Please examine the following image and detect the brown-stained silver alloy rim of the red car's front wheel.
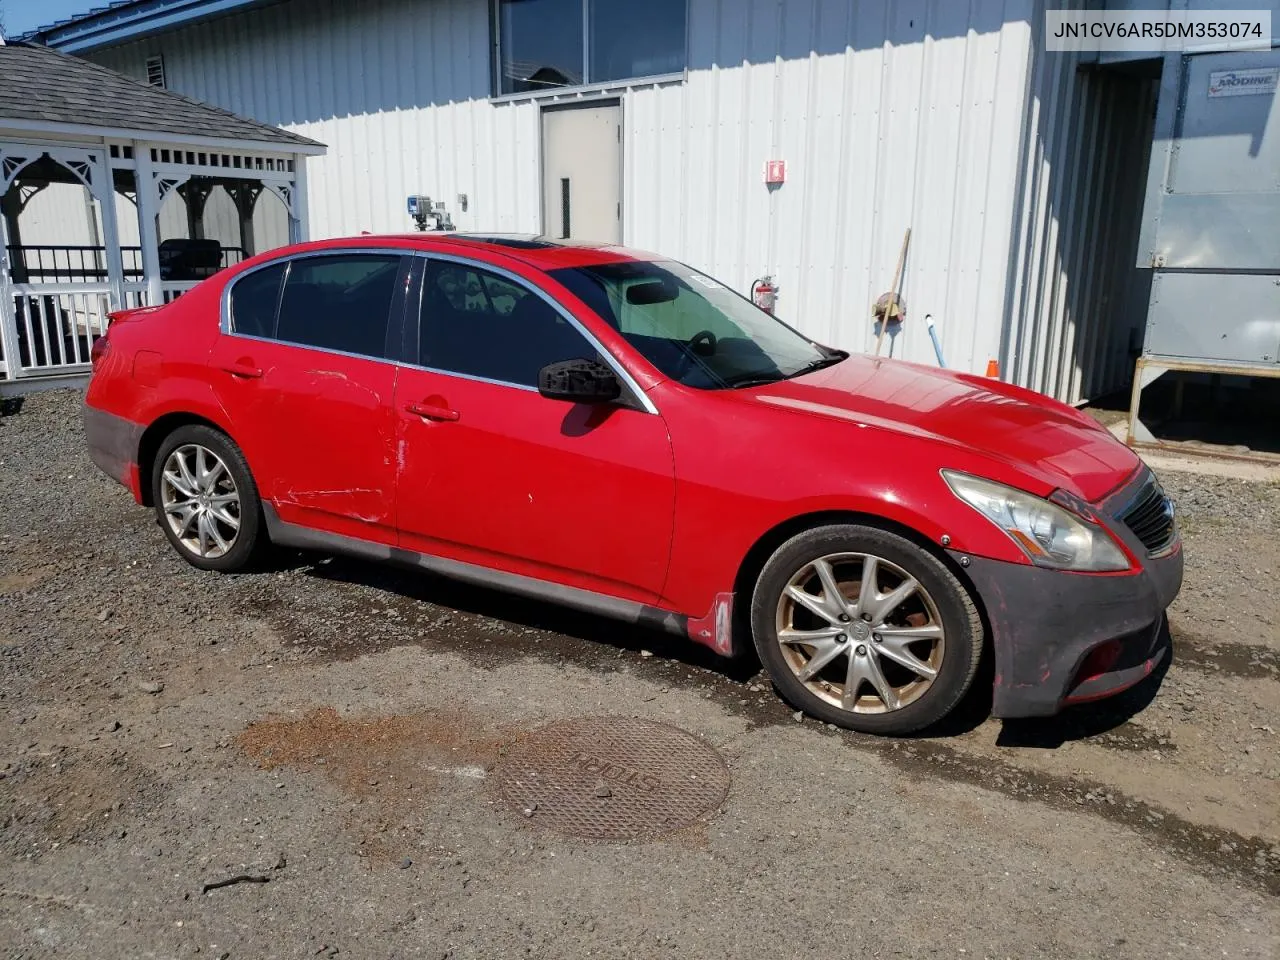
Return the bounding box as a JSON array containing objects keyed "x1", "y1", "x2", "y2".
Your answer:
[{"x1": 776, "y1": 553, "x2": 946, "y2": 713}]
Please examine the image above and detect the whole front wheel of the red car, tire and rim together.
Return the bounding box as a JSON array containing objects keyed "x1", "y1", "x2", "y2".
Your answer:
[{"x1": 751, "y1": 525, "x2": 983, "y2": 736}]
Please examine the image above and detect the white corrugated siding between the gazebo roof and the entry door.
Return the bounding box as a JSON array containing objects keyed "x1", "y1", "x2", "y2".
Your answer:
[{"x1": 91, "y1": 0, "x2": 540, "y2": 237}]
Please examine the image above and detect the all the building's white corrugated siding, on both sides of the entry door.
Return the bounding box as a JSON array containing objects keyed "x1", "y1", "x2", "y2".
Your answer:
[{"x1": 93, "y1": 0, "x2": 1126, "y2": 399}]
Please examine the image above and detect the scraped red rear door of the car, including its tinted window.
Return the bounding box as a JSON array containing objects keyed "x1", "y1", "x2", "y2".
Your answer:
[{"x1": 210, "y1": 251, "x2": 410, "y2": 544}]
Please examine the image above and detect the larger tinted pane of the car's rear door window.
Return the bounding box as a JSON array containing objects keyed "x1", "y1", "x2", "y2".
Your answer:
[{"x1": 275, "y1": 253, "x2": 401, "y2": 357}]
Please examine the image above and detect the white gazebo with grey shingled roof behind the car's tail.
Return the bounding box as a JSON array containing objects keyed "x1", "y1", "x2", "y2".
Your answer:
[{"x1": 0, "y1": 40, "x2": 325, "y2": 394}]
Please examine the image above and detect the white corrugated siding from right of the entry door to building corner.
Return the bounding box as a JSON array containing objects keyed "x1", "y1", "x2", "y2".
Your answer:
[{"x1": 623, "y1": 0, "x2": 1030, "y2": 370}]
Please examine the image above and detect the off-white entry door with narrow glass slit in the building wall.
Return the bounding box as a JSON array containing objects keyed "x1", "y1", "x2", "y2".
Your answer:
[{"x1": 543, "y1": 100, "x2": 622, "y2": 243}]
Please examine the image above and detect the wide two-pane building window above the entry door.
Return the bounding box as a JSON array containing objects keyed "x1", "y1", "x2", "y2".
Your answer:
[{"x1": 498, "y1": 0, "x2": 687, "y2": 93}]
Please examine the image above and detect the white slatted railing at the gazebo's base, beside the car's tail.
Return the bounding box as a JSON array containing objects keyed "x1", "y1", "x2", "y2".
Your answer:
[{"x1": 6, "y1": 283, "x2": 111, "y2": 376}]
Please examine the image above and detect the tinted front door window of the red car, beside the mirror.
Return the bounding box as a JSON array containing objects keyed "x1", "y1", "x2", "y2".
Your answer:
[{"x1": 419, "y1": 260, "x2": 598, "y2": 387}]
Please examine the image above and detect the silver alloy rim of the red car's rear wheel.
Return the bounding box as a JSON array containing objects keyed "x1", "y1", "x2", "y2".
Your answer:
[{"x1": 160, "y1": 443, "x2": 241, "y2": 559}]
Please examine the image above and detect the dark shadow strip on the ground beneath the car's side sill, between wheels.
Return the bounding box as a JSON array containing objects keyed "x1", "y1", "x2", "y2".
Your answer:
[{"x1": 294, "y1": 554, "x2": 760, "y2": 684}]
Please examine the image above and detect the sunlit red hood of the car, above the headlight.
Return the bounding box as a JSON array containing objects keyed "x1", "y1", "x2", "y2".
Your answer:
[{"x1": 735, "y1": 356, "x2": 1142, "y2": 502}]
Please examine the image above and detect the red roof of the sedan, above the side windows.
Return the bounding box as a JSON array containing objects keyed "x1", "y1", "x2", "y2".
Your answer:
[{"x1": 280, "y1": 232, "x2": 662, "y2": 270}]
